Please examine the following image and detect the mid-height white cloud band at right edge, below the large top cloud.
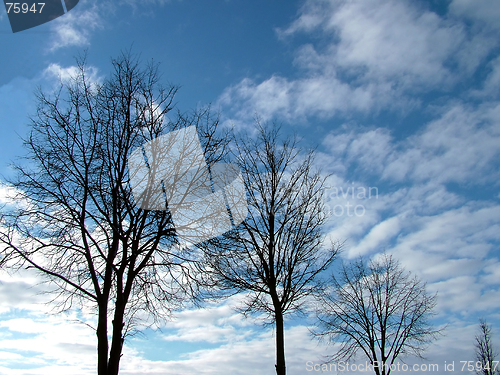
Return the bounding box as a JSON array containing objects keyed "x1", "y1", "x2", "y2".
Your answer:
[{"x1": 322, "y1": 102, "x2": 500, "y2": 186}]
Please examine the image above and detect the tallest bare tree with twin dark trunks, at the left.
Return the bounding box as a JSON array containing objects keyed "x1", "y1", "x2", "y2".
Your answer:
[{"x1": 0, "y1": 53, "x2": 225, "y2": 375}]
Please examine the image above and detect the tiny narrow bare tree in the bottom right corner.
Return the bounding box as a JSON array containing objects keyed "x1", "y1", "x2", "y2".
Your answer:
[{"x1": 475, "y1": 319, "x2": 500, "y2": 375}]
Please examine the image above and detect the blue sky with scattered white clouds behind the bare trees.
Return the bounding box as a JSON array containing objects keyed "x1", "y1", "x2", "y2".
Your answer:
[{"x1": 0, "y1": 0, "x2": 500, "y2": 375}]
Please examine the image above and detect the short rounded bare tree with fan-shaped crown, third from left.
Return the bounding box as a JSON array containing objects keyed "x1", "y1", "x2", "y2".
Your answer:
[{"x1": 313, "y1": 254, "x2": 440, "y2": 375}]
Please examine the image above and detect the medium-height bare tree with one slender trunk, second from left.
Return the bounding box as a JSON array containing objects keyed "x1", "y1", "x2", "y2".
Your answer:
[{"x1": 205, "y1": 124, "x2": 339, "y2": 375}]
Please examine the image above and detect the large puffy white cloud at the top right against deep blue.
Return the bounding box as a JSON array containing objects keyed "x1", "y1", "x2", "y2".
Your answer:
[{"x1": 219, "y1": 0, "x2": 498, "y2": 125}]
